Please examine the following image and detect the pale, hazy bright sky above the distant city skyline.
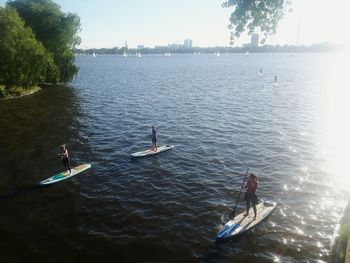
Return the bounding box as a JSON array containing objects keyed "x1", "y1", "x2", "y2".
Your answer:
[{"x1": 0, "y1": 0, "x2": 350, "y2": 49}]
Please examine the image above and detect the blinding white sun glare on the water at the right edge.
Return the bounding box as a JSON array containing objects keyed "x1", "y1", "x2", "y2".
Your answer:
[{"x1": 323, "y1": 53, "x2": 350, "y2": 189}]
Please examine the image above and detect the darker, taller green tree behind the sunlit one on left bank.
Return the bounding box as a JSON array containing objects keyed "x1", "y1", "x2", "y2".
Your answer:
[{"x1": 7, "y1": 0, "x2": 81, "y2": 83}]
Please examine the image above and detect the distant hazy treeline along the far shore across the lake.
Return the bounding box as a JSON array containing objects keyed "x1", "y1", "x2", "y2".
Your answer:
[{"x1": 73, "y1": 43, "x2": 344, "y2": 55}]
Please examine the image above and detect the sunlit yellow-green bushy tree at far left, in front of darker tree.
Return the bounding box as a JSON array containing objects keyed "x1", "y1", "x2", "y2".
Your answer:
[{"x1": 0, "y1": 7, "x2": 54, "y2": 89}]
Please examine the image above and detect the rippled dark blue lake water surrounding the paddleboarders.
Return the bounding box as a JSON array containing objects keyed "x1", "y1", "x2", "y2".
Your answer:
[{"x1": 0, "y1": 54, "x2": 349, "y2": 262}]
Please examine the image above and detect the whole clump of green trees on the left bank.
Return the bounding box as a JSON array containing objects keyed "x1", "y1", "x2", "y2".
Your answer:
[{"x1": 0, "y1": 0, "x2": 81, "y2": 90}]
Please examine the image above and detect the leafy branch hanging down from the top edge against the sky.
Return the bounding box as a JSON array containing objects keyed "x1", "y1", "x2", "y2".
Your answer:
[{"x1": 222, "y1": 0, "x2": 290, "y2": 45}]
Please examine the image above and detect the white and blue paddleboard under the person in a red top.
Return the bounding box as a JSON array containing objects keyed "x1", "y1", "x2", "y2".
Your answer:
[{"x1": 216, "y1": 201, "x2": 277, "y2": 241}]
